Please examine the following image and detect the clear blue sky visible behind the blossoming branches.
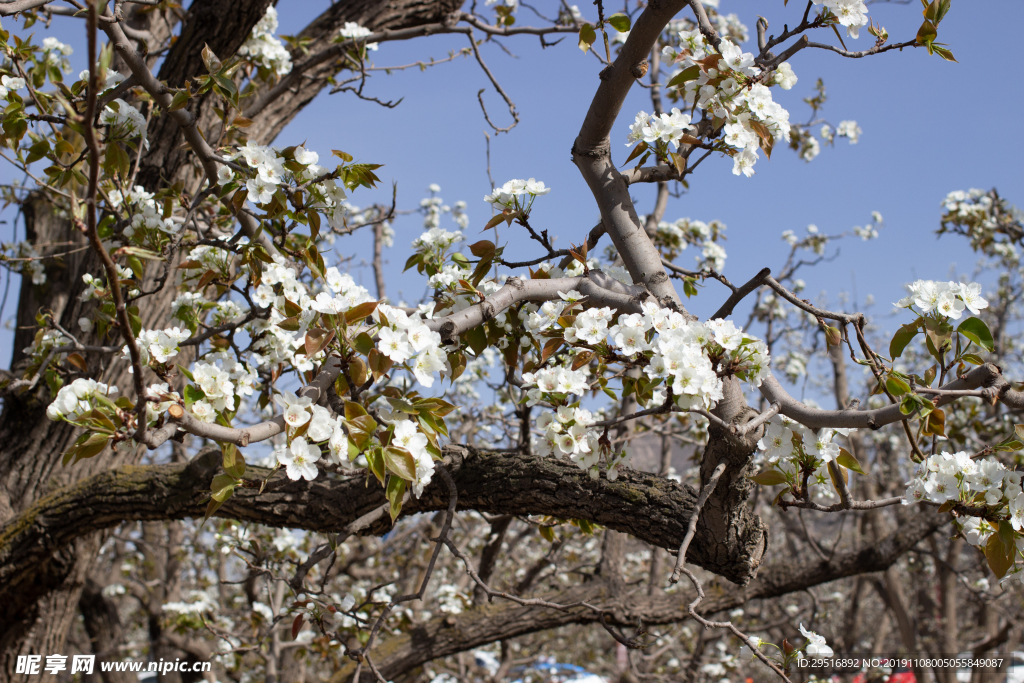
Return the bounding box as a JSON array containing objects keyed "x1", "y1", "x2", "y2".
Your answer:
[{"x1": 0, "y1": 0, "x2": 1024, "y2": 362}]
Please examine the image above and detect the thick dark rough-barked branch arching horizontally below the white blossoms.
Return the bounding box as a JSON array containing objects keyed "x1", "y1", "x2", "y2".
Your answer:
[{"x1": 0, "y1": 446, "x2": 767, "y2": 602}]
